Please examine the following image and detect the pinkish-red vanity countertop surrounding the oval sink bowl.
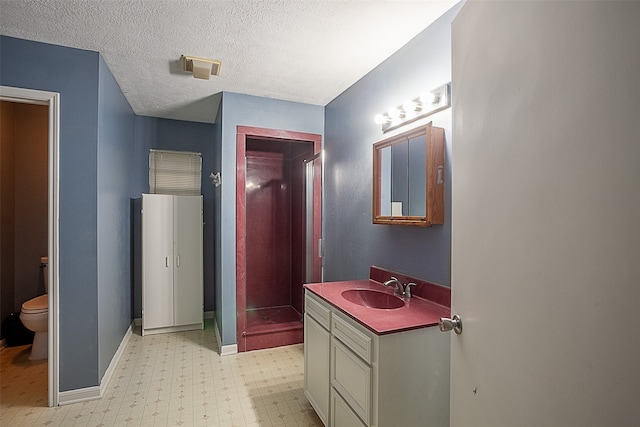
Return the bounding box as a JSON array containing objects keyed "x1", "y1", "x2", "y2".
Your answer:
[{"x1": 304, "y1": 280, "x2": 451, "y2": 335}]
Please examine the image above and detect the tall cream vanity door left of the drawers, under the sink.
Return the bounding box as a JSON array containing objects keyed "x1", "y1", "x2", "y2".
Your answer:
[{"x1": 304, "y1": 314, "x2": 330, "y2": 425}]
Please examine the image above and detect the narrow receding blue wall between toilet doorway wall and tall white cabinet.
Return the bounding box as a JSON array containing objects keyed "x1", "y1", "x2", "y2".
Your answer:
[{"x1": 97, "y1": 57, "x2": 135, "y2": 378}]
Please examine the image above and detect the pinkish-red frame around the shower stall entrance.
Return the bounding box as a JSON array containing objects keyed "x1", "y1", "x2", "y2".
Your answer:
[{"x1": 236, "y1": 126, "x2": 322, "y2": 352}]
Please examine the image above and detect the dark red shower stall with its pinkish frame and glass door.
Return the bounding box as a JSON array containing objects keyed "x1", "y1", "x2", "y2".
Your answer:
[{"x1": 236, "y1": 128, "x2": 322, "y2": 351}]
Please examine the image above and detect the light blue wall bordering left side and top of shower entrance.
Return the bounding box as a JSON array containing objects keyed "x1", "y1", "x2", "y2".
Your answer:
[{"x1": 215, "y1": 92, "x2": 324, "y2": 345}]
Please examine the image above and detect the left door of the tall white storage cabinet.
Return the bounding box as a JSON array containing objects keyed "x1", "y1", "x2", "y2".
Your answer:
[{"x1": 142, "y1": 194, "x2": 173, "y2": 330}]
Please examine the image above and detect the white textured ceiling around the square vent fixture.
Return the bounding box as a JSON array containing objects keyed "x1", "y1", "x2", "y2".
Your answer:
[{"x1": 0, "y1": 0, "x2": 457, "y2": 123}]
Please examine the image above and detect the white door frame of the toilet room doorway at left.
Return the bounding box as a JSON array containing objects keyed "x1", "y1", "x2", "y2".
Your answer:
[{"x1": 0, "y1": 86, "x2": 60, "y2": 407}]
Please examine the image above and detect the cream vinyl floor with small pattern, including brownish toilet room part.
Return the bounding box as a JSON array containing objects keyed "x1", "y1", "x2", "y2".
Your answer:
[{"x1": 0, "y1": 321, "x2": 322, "y2": 427}]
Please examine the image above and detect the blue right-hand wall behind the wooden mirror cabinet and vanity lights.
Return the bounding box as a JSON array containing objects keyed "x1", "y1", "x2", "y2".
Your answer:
[{"x1": 323, "y1": 5, "x2": 461, "y2": 286}]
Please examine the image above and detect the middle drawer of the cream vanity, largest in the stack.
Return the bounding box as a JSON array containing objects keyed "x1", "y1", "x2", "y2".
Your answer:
[{"x1": 330, "y1": 340, "x2": 372, "y2": 425}]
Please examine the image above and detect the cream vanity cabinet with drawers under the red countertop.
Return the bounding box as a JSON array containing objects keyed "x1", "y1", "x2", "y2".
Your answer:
[{"x1": 305, "y1": 290, "x2": 450, "y2": 427}]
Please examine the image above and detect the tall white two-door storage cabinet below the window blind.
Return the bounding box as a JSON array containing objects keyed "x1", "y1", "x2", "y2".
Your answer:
[{"x1": 142, "y1": 194, "x2": 204, "y2": 335}]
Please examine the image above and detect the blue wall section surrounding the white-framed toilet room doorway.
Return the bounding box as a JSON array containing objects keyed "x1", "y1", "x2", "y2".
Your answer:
[{"x1": 0, "y1": 36, "x2": 99, "y2": 391}]
